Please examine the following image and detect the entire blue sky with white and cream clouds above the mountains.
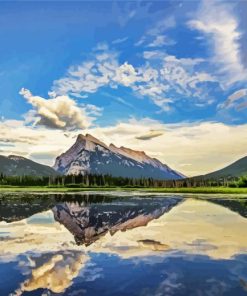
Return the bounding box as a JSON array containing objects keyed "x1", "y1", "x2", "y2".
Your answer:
[{"x1": 0, "y1": 0, "x2": 247, "y2": 176}]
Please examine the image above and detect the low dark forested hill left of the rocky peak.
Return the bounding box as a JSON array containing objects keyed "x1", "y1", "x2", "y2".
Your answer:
[{"x1": 0, "y1": 155, "x2": 58, "y2": 176}]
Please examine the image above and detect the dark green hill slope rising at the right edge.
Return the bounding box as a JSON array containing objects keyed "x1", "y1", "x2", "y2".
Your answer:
[{"x1": 202, "y1": 156, "x2": 247, "y2": 179}]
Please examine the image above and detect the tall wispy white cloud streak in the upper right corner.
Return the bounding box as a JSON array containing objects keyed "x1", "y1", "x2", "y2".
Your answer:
[{"x1": 188, "y1": 0, "x2": 246, "y2": 86}]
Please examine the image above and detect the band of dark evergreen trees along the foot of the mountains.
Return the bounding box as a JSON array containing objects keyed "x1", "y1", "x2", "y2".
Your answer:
[{"x1": 0, "y1": 174, "x2": 247, "y2": 188}]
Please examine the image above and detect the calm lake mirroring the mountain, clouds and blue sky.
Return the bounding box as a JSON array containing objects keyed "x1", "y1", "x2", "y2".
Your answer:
[{"x1": 0, "y1": 194, "x2": 247, "y2": 296}]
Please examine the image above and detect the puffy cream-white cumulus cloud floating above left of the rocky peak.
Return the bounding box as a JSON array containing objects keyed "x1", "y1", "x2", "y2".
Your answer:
[{"x1": 20, "y1": 88, "x2": 94, "y2": 130}]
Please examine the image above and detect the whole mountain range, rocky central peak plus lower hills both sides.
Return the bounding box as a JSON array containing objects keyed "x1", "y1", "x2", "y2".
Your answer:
[{"x1": 0, "y1": 134, "x2": 247, "y2": 180}]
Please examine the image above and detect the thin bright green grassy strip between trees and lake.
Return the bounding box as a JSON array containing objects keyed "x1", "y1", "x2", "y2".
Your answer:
[{"x1": 0, "y1": 186, "x2": 247, "y2": 194}]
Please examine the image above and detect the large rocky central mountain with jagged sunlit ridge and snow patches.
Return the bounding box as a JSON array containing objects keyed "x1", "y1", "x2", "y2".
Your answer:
[{"x1": 53, "y1": 134, "x2": 184, "y2": 179}]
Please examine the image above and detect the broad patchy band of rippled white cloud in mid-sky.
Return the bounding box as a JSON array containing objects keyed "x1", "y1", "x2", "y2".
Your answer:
[{"x1": 53, "y1": 44, "x2": 216, "y2": 111}]
